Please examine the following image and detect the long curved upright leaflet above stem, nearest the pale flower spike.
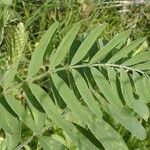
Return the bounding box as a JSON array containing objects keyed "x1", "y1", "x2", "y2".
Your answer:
[{"x1": 28, "y1": 22, "x2": 59, "y2": 77}]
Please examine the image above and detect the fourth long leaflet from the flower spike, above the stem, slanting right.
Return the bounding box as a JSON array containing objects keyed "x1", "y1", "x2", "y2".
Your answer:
[{"x1": 90, "y1": 30, "x2": 131, "y2": 64}]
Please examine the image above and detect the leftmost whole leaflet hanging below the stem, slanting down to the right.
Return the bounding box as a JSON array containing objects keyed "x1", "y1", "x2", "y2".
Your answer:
[{"x1": 5, "y1": 94, "x2": 39, "y2": 133}]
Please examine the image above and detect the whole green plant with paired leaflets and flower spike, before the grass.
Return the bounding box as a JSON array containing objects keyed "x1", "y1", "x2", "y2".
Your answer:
[{"x1": 0, "y1": 22, "x2": 150, "y2": 150}]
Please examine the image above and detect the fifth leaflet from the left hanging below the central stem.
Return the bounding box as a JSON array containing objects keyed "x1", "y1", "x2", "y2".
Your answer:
[{"x1": 91, "y1": 68, "x2": 122, "y2": 109}]
